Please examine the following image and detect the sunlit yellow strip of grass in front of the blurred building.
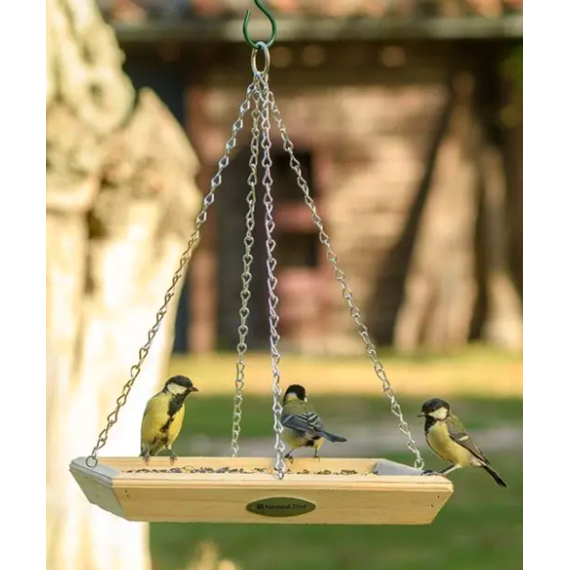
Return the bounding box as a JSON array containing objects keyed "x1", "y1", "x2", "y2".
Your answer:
[{"x1": 169, "y1": 346, "x2": 523, "y2": 397}]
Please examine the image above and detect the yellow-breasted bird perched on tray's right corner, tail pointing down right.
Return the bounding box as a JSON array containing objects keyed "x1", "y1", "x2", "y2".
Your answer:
[{"x1": 418, "y1": 398, "x2": 507, "y2": 488}]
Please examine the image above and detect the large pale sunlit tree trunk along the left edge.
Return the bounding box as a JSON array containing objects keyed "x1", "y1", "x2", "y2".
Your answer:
[{"x1": 46, "y1": 0, "x2": 200, "y2": 570}]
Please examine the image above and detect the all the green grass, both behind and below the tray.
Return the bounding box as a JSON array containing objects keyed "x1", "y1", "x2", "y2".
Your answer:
[{"x1": 151, "y1": 396, "x2": 523, "y2": 570}]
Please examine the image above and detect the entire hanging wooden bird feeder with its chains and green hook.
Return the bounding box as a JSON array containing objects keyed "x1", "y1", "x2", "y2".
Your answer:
[{"x1": 70, "y1": 0, "x2": 453, "y2": 525}]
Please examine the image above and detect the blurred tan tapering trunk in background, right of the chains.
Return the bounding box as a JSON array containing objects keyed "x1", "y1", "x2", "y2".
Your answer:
[{"x1": 395, "y1": 74, "x2": 481, "y2": 351}]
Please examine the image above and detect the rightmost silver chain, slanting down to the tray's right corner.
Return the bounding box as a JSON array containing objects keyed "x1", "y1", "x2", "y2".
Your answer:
[{"x1": 268, "y1": 92, "x2": 425, "y2": 469}]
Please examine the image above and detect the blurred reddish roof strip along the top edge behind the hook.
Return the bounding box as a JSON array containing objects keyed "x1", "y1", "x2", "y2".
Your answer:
[{"x1": 96, "y1": 0, "x2": 524, "y2": 41}]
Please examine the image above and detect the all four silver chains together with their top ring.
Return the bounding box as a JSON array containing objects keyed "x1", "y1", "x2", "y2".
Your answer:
[{"x1": 86, "y1": 38, "x2": 425, "y2": 479}]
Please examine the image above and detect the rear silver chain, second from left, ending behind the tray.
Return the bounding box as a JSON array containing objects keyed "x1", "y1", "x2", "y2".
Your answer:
[{"x1": 232, "y1": 85, "x2": 260, "y2": 457}]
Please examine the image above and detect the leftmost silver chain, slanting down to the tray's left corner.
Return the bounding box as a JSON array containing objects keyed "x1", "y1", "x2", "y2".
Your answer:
[{"x1": 86, "y1": 83, "x2": 255, "y2": 468}]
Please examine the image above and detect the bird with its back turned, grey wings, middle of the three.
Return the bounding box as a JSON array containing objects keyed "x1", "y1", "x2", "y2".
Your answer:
[{"x1": 281, "y1": 384, "x2": 347, "y2": 461}]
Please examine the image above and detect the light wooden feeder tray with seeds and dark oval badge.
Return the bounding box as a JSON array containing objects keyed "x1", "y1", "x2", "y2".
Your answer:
[{"x1": 71, "y1": 457, "x2": 453, "y2": 525}]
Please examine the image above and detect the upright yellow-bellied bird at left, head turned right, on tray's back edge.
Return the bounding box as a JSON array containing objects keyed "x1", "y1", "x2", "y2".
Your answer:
[{"x1": 140, "y1": 376, "x2": 198, "y2": 465}]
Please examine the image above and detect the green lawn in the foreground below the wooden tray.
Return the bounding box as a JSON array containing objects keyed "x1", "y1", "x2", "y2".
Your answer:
[{"x1": 151, "y1": 454, "x2": 523, "y2": 570}]
